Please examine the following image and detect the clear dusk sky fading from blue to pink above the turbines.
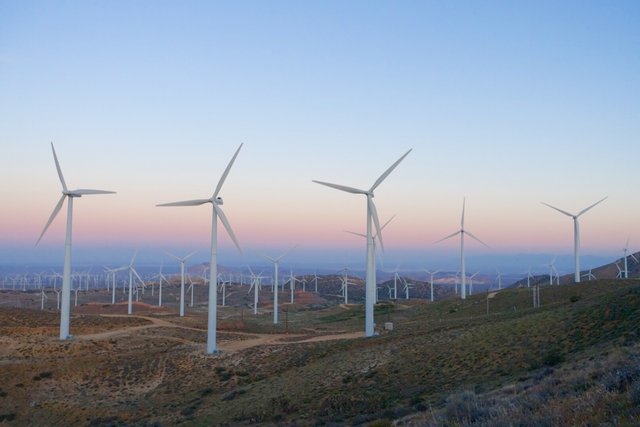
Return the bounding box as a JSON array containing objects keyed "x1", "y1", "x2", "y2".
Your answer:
[{"x1": 0, "y1": 0, "x2": 640, "y2": 269}]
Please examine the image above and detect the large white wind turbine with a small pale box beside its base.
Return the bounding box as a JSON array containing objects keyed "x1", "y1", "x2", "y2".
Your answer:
[{"x1": 313, "y1": 150, "x2": 411, "y2": 337}]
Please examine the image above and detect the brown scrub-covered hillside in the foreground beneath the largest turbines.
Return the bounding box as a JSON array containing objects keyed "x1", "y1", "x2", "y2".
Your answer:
[{"x1": 0, "y1": 279, "x2": 640, "y2": 425}]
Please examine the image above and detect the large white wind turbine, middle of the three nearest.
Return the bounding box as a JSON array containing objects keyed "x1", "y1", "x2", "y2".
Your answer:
[{"x1": 158, "y1": 144, "x2": 242, "y2": 354}]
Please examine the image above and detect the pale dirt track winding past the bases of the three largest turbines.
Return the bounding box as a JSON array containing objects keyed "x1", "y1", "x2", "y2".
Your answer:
[{"x1": 74, "y1": 314, "x2": 364, "y2": 352}]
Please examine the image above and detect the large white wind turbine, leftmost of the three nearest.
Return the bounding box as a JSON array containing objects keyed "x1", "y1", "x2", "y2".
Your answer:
[{"x1": 36, "y1": 142, "x2": 115, "y2": 340}]
